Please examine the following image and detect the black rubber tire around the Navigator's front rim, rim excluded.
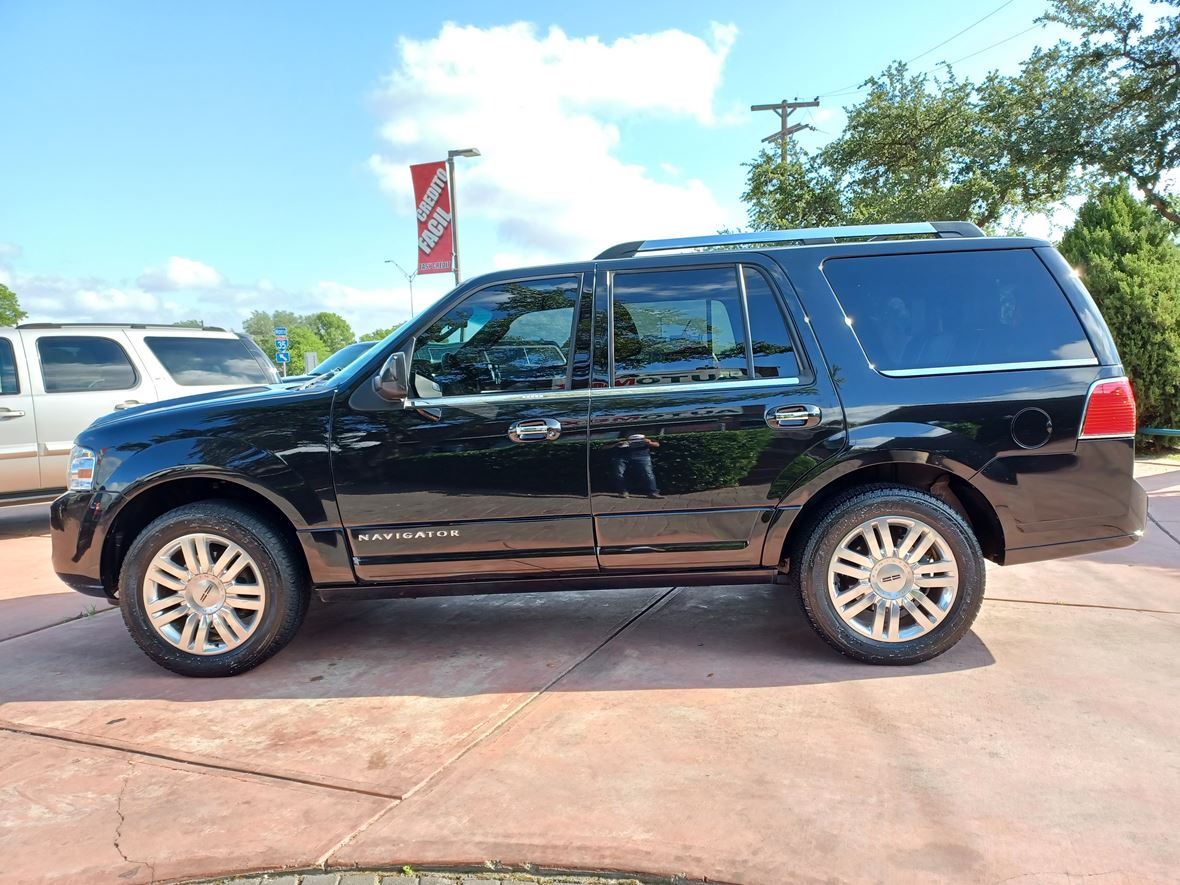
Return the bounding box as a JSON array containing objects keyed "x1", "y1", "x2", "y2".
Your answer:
[{"x1": 119, "y1": 500, "x2": 310, "y2": 676}]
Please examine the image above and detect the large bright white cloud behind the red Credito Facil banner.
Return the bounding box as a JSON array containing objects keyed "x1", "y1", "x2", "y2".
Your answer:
[{"x1": 369, "y1": 24, "x2": 736, "y2": 264}]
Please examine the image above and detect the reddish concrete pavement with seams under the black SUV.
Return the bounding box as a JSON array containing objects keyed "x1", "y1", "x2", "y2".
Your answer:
[{"x1": 0, "y1": 465, "x2": 1180, "y2": 885}]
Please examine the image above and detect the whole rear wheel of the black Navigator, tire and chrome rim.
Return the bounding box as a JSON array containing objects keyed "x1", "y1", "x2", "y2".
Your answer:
[{"x1": 792, "y1": 486, "x2": 985, "y2": 664}]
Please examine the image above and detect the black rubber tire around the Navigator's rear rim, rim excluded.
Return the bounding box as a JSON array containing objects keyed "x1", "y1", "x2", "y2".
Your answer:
[{"x1": 791, "y1": 485, "x2": 986, "y2": 664}]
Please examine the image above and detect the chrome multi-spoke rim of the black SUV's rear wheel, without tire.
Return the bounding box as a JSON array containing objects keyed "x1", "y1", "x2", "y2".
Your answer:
[{"x1": 827, "y1": 516, "x2": 959, "y2": 642}]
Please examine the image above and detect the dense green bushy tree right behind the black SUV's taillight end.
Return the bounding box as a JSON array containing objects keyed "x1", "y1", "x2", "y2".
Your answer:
[{"x1": 1061, "y1": 182, "x2": 1180, "y2": 427}]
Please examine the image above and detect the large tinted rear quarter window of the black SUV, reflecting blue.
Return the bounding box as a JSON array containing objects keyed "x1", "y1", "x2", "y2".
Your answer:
[{"x1": 824, "y1": 249, "x2": 1095, "y2": 373}]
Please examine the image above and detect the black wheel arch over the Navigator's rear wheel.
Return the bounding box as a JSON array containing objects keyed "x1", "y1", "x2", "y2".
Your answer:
[{"x1": 763, "y1": 451, "x2": 1005, "y2": 570}]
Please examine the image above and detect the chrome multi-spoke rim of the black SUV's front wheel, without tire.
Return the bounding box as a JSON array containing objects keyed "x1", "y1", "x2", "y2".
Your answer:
[{"x1": 143, "y1": 532, "x2": 267, "y2": 655}]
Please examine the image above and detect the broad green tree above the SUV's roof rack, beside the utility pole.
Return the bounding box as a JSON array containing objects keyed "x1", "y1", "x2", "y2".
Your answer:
[{"x1": 743, "y1": 63, "x2": 1073, "y2": 229}]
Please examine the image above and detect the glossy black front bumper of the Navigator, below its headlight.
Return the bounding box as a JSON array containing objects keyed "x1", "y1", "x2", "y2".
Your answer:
[{"x1": 50, "y1": 492, "x2": 118, "y2": 599}]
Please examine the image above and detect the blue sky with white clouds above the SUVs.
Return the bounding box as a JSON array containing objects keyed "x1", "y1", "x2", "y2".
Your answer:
[{"x1": 0, "y1": 0, "x2": 1128, "y2": 332}]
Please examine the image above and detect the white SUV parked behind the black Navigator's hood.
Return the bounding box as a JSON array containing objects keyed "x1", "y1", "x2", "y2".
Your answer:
[{"x1": 0, "y1": 323, "x2": 278, "y2": 504}]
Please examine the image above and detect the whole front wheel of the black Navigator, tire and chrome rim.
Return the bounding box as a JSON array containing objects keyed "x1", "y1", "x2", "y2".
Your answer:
[{"x1": 119, "y1": 502, "x2": 309, "y2": 676}]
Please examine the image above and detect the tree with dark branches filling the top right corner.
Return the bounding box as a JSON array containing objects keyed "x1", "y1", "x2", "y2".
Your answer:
[{"x1": 1043, "y1": 0, "x2": 1180, "y2": 224}]
